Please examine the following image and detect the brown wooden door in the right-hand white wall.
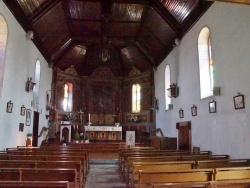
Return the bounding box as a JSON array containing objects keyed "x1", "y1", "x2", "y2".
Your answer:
[{"x1": 176, "y1": 121, "x2": 192, "y2": 151}]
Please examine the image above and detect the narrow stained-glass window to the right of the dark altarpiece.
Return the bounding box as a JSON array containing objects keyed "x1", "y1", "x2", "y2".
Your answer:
[{"x1": 132, "y1": 84, "x2": 141, "y2": 112}]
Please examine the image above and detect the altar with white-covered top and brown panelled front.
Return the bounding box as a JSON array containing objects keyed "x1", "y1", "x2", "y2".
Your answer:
[{"x1": 85, "y1": 125, "x2": 122, "y2": 141}]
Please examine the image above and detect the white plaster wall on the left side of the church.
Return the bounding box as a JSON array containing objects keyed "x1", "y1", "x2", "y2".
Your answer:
[{"x1": 0, "y1": 1, "x2": 52, "y2": 150}]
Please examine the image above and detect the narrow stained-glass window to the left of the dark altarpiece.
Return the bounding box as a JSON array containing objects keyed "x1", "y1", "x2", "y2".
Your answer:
[{"x1": 63, "y1": 83, "x2": 73, "y2": 111}]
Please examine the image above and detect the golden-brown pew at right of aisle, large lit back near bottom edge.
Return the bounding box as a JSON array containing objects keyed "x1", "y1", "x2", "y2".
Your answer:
[{"x1": 136, "y1": 169, "x2": 213, "y2": 188}]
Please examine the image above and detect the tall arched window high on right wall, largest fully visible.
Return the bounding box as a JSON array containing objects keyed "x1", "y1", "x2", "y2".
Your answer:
[{"x1": 198, "y1": 27, "x2": 214, "y2": 99}]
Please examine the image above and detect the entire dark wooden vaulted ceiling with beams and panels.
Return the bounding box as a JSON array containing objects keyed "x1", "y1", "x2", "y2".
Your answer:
[{"x1": 3, "y1": 0, "x2": 212, "y2": 77}]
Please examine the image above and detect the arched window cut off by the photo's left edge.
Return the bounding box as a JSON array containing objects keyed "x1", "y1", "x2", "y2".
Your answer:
[{"x1": 0, "y1": 15, "x2": 8, "y2": 96}]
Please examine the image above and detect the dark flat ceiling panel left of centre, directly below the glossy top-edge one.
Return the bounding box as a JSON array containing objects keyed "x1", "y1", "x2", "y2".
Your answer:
[{"x1": 69, "y1": 21, "x2": 101, "y2": 38}]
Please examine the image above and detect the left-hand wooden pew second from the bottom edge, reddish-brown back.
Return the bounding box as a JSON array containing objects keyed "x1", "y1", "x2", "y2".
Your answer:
[{"x1": 0, "y1": 168, "x2": 79, "y2": 188}]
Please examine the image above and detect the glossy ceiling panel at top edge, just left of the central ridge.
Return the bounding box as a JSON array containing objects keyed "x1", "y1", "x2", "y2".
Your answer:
[{"x1": 69, "y1": 1, "x2": 102, "y2": 20}]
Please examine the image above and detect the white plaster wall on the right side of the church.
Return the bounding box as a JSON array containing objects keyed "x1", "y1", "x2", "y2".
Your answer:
[{"x1": 155, "y1": 2, "x2": 250, "y2": 158}]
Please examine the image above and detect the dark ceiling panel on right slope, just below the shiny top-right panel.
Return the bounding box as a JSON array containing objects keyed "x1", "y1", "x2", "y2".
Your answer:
[{"x1": 145, "y1": 9, "x2": 176, "y2": 46}]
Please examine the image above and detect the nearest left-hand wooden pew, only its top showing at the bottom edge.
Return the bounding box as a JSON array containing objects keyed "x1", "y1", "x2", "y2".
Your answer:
[{"x1": 0, "y1": 180, "x2": 69, "y2": 188}]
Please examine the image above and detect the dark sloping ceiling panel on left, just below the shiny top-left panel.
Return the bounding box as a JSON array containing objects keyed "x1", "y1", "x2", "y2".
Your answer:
[{"x1": 33, "y1": 3, "x2": 69, "y2": 41}]
